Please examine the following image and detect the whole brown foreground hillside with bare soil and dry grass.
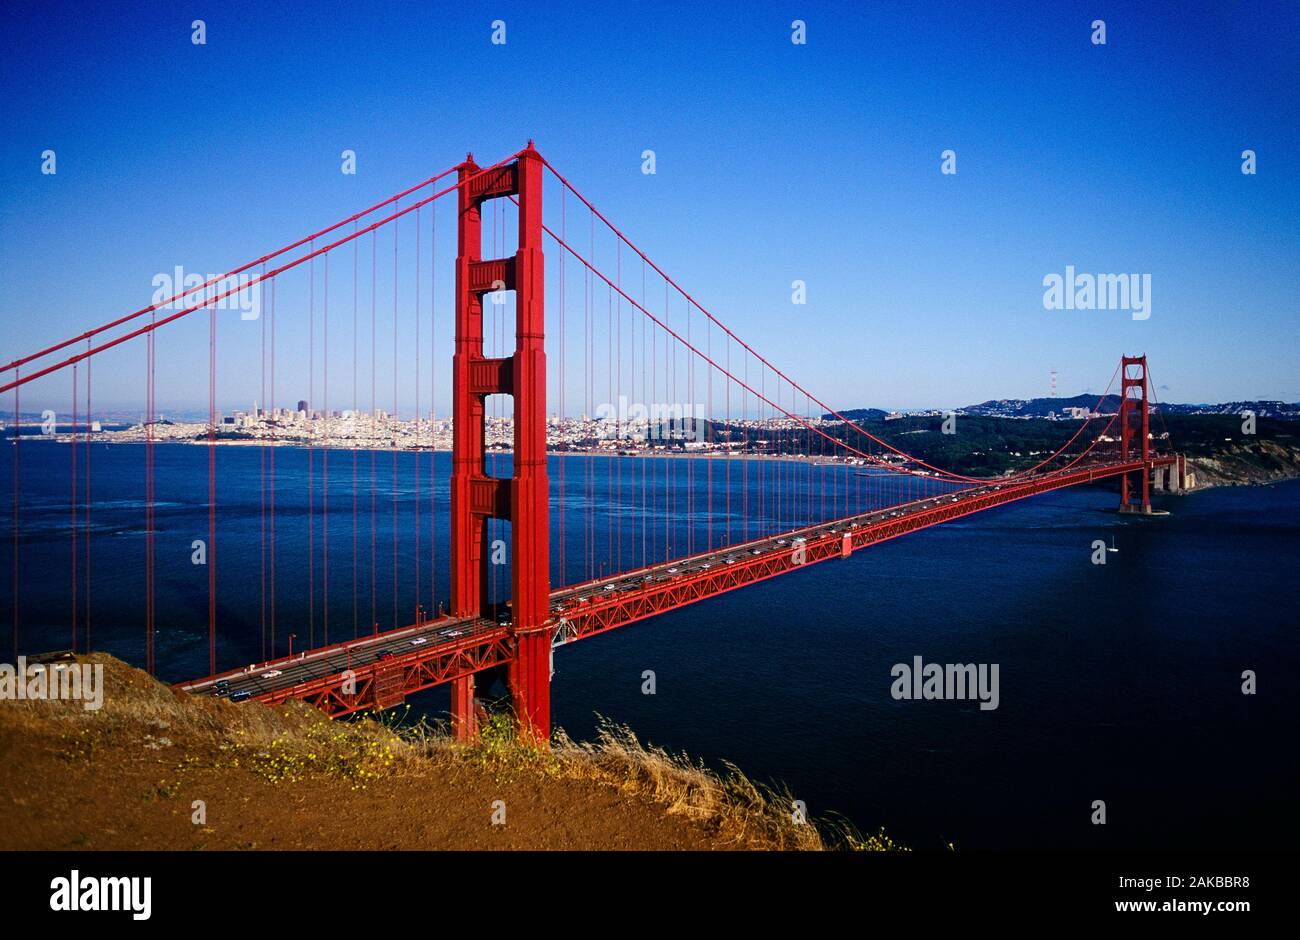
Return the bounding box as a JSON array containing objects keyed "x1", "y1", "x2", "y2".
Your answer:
[{"x1": 0, "y1": 654, "x2": 880, "y2": 850}]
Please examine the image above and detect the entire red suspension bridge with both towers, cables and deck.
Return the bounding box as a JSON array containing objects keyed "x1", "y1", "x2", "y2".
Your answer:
[{"x1": 0, "y1": 143, "x2": 1183, "y2": 740}]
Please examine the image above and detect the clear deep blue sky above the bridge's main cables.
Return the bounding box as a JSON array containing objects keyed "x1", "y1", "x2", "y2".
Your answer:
[{"x1": 0, "y1": 0, "x2": 1300, "y2": 407}]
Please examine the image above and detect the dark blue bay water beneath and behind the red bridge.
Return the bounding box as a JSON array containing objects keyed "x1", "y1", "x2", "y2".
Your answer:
[{"x1": 0, "y1": 441, "x2": 1300, "y2": 848}]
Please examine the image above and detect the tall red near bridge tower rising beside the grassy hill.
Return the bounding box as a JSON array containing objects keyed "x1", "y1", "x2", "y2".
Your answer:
[{"x1": 451, "y1": 140, "x2": 551, "y2": 742}]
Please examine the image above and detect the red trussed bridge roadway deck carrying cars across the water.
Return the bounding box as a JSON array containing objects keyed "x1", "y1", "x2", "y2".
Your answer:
[{"x1": 178, "y1": 458, "x2": 1174, "y2": 715}]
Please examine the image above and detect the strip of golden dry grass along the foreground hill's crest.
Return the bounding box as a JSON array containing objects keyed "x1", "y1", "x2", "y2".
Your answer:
[{"x1": 4, "y1": 654, "x2": 900, "y2": 850}]
